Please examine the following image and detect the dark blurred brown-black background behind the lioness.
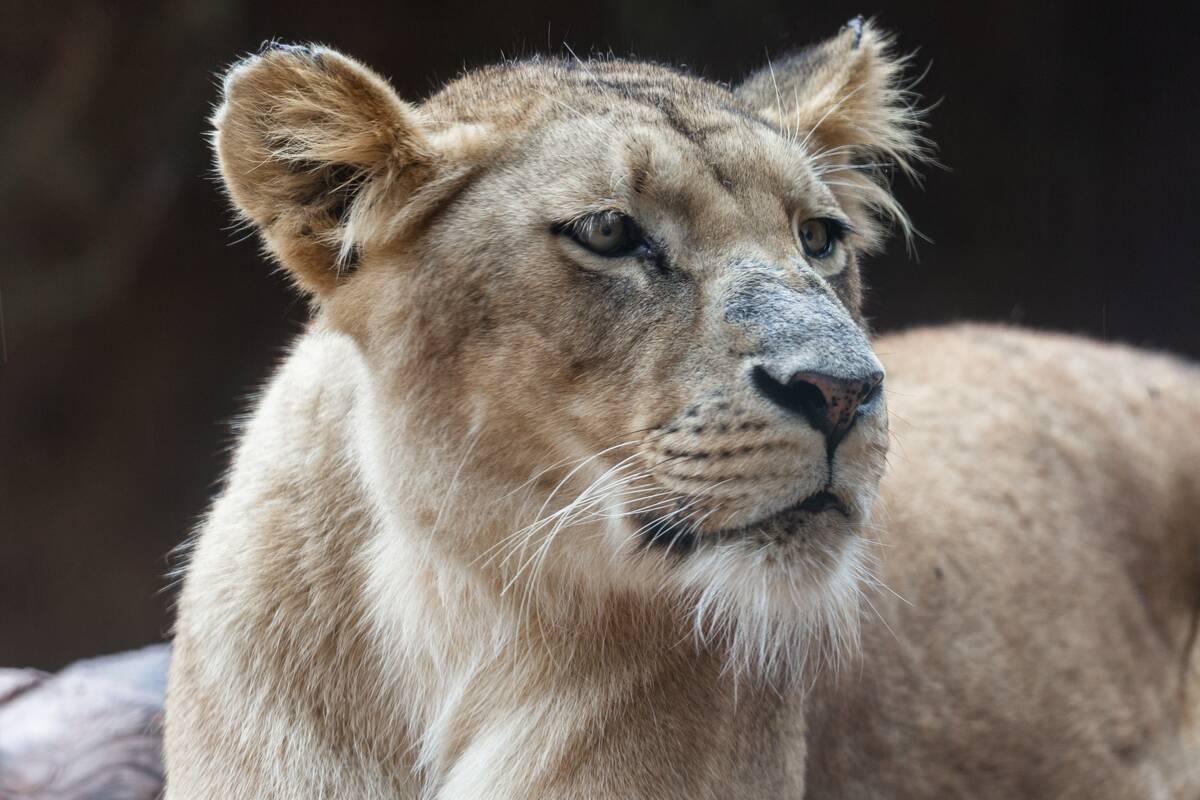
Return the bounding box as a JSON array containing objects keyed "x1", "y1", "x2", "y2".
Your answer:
[{"x1": 0, "y1": 0, "x2": 1200, "y2": 668}]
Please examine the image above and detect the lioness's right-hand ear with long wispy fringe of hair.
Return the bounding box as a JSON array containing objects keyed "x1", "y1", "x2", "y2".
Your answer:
[{"x1": 734, "y1": 17, "x2": 935, "y2": 251}]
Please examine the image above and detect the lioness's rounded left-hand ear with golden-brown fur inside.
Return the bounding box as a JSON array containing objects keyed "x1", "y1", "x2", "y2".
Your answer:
[{"x1": 214, "y1": 43, "x2": 438, "y2": 297}]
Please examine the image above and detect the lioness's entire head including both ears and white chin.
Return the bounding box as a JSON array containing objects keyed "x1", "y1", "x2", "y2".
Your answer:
[{"x1": 217, "y1": 21, "x2": 919, "y2": 671}]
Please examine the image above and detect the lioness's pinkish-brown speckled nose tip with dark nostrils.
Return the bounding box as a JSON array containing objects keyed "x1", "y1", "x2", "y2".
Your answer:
[{"x1": 752, "y1": 366, "x2": 883, "y2": 451}]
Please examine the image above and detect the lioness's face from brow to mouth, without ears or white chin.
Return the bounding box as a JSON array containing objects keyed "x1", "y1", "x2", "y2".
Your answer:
[{"x1": 420, "y1": 92, "x2": 886, "y2": 537}]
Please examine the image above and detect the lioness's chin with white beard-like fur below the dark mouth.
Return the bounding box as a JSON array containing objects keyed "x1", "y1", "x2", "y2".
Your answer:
[{"x1": 634, "y1": 479, "x2": 874, "y2": 686}]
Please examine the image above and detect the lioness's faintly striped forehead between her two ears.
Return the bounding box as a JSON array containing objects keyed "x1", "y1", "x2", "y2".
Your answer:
[{"x1": 426, "y1": 60, "x2": 828, "y2": 214}]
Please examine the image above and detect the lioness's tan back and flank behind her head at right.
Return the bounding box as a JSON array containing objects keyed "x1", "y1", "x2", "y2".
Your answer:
[{"x1": 806, "y1": 326, "x2": 1200, "y2": 799}]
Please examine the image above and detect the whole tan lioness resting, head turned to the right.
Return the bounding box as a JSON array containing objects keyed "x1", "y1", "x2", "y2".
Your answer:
[{"x1": 166, "y1": 20, "x2": 1200, "y2": 800}]
